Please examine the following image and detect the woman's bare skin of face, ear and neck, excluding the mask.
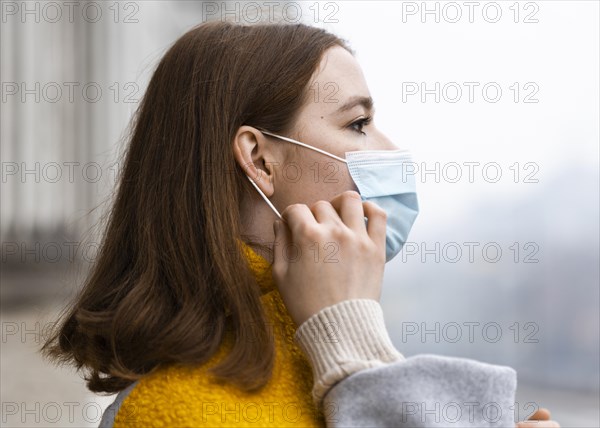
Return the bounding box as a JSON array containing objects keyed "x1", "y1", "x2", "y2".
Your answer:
[{"x1": 233, "y1": 46, "x2": 399, "y2": 234}]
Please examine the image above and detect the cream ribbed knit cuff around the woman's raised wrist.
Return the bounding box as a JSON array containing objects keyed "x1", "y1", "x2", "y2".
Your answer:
[{"x1": 294, "y1": 299, "x2": 404, "y2": 406}]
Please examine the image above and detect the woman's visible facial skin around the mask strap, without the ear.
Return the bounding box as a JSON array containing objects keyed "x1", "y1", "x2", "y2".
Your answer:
[{"x1": 266, "y1": 46, "x2": 399, "y2": 212}]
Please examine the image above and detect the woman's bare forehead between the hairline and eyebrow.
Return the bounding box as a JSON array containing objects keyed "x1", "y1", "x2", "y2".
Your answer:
[{"x1": 306, "y1": 46, "x2": 370, "y2": 114}]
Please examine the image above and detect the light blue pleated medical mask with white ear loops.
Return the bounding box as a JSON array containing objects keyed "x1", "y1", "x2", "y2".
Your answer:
[{"x1": 246, "y1": 131, "x2": 419, "y2": 262}]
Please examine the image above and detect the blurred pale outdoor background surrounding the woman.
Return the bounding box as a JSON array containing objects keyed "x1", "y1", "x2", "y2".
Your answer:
[{"x1": 0, "y1": 1, "x2": 600, "y2": 427}]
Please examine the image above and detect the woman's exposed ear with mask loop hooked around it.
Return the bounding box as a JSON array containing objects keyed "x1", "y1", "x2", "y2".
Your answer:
[{"x1": 233, "y1": 125, "x2": 277, "y2": 197}]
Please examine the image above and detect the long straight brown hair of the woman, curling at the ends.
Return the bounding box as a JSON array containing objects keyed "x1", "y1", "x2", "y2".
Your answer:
[{"x1": 41, "y1": 21, "x2": 352, "y2": 393}]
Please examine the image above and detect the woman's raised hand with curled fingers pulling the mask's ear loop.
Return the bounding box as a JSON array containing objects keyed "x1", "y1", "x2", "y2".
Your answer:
[{"x1": 273, "y1": 191, "x2": 386, "y2": 326}]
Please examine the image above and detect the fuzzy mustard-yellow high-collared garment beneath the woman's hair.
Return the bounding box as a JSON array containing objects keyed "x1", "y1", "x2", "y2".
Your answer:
[{"x1": 113, "y1": 244, "x2": 325, "y2": 428}]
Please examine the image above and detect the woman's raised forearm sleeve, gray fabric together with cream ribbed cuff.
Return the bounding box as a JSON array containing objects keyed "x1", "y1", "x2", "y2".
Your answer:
[{"x1": 295, "y1": 299, "x2": 517, "y2": 428}]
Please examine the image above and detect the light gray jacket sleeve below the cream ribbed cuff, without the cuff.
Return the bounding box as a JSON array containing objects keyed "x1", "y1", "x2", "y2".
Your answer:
[{"x1": 323, "y1": 354, "x2": 517, "y2": 427}]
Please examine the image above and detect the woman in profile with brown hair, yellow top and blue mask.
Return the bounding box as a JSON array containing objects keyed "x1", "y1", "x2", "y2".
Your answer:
[{"x1": 43, "y1": 18, "x2": 556, "y2": 427}]
